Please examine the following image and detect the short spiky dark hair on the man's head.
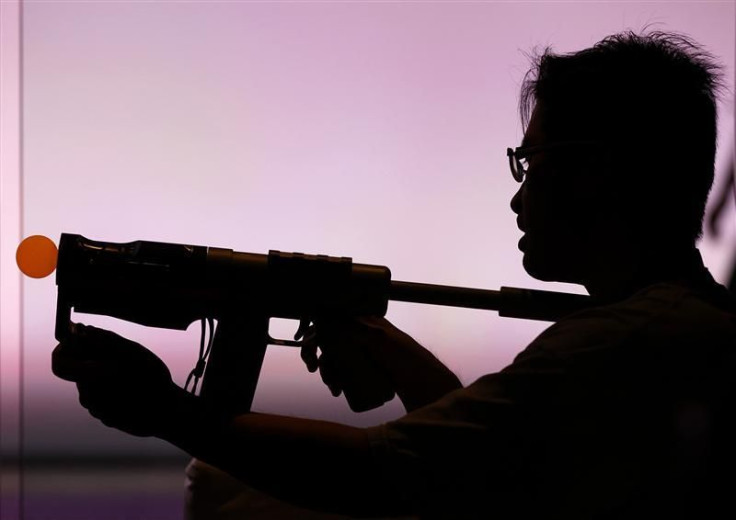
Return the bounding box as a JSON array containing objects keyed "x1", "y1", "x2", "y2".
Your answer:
[{"x1": 519, "y1": 31, "x2": 725, "y2": 242}]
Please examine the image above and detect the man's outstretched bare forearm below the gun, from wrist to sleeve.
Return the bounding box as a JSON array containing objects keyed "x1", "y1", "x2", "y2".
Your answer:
[{"x1": 158, "y1": 391, "x2": 406, "y2": 516}]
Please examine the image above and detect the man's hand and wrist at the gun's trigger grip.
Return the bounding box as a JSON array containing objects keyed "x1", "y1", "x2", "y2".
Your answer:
[{"x1": 301, "y1": 316, "x2": 462, "y2": 411}]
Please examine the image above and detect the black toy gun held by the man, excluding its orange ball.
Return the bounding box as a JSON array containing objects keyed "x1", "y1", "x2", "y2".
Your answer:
[{"x1": 55, "y1": 233, "x2": 590, "y2": 413}]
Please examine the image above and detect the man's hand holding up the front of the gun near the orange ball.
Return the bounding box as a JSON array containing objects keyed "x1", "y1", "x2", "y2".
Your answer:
[{"x1": 51, "y1": 324, "x2": 182, "y2": 436}]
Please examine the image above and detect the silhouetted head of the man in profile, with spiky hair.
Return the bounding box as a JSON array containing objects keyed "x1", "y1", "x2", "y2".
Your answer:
[{"x1": 512, "y1": 32, "x2": 722, "y2": 282}]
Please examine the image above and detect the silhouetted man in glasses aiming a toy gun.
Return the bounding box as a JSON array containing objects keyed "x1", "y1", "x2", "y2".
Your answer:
[{"x1": 54, "y1": 33, "x2": 736, "y2": 520}]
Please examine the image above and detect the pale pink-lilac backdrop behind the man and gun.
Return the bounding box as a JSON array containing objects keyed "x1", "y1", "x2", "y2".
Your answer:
[{"x1": 3, "y1": 1, "x2": 736, "y2": 455}]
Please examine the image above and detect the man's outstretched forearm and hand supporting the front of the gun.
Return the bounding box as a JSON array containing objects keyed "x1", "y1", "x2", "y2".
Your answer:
[{"x1": 52, "y1": 326, "x2": 414, "y2": 517}]
